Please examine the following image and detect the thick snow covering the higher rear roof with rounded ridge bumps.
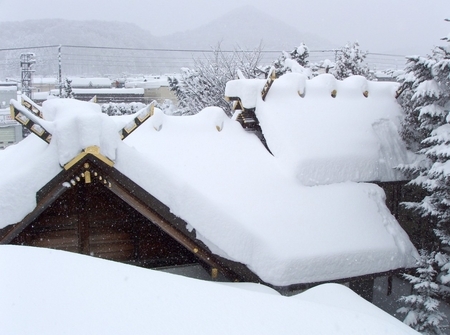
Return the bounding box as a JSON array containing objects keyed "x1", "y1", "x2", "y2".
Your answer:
[{"x1": 225, "y1": 73, "x2": 412, "y2": 185}]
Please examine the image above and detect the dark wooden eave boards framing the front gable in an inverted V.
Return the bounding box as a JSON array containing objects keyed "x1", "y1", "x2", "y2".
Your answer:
[{"x1": 0, "y1": 153, "x2": 263, "y2": 283}]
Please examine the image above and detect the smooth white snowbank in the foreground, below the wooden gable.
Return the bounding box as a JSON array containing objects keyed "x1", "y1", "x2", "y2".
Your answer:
[{"x1": 0, "y1": 246, "x2": 417, "y2": 335}]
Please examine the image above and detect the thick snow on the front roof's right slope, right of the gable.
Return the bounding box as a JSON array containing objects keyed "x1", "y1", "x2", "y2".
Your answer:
[{"x1": 116, "y1": 108, "x2": 414, "y2": 285}]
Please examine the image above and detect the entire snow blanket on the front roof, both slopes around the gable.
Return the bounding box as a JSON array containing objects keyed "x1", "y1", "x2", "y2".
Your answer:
[{"x1": 0, "y1": 91, "x2": 416, "y2": 286}]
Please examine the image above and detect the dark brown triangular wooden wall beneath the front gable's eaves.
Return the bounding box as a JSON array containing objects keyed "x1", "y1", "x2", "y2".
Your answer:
[{"x1": 11, "y1": 182, "x2": 198, "y2": 268}]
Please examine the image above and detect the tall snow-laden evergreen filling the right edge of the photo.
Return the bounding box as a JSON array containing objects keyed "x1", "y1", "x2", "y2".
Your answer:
[{"x1": 398, "y1": 19, "x2": 450, "y2": 334}]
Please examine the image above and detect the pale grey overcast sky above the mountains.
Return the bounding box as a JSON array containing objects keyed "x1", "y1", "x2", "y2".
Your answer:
[{"x1": 0, "y1": 0, "x2": 450, "y2": 54}]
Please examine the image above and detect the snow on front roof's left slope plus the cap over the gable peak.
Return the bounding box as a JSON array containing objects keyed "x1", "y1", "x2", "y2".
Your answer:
[{"x1": 0, "y1": 99, "x2": 120, "y2": 227}]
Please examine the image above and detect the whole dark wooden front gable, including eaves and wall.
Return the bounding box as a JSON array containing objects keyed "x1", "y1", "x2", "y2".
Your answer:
[{"x1": 0, "y1": 152, "x2": 261, "y2": 282}]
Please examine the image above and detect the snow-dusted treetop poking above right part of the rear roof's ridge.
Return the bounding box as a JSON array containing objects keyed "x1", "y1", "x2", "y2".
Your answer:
[{"x1": 332, "y1": 42, "x2": 373, "y2": 80}]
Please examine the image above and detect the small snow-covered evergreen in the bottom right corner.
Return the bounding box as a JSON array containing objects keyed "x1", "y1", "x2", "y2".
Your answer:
[{"x1": 397, "y1": 250, "x2": 445, "y2": 335}]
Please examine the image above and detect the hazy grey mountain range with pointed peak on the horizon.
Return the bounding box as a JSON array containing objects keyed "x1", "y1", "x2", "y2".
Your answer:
[{"x1": 0, "y1": 6, "x2": 331, "y2": 80}]
